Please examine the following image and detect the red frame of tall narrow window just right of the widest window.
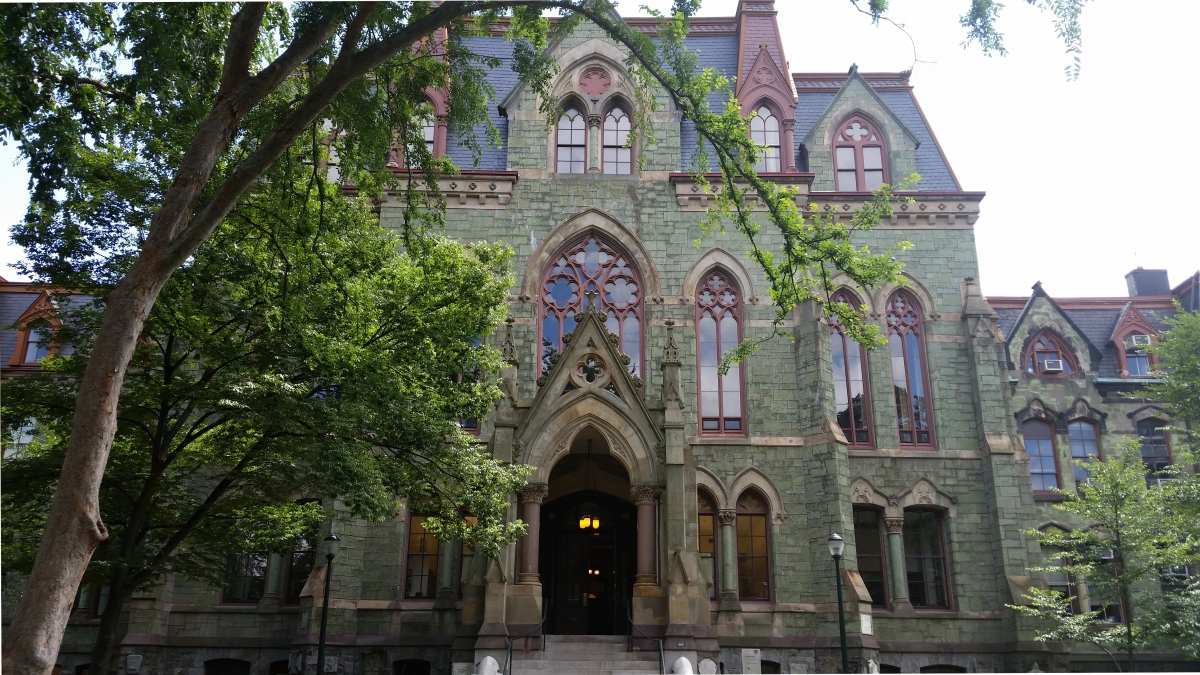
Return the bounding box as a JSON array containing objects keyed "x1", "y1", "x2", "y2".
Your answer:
[{"x1": 695, "y1": 267, "x2": 750, "y2": 437}]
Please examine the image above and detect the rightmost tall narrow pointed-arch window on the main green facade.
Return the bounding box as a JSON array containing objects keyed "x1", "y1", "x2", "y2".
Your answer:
[{"x1": 887, "y1": 291, "x2": 934, "y2": 447}]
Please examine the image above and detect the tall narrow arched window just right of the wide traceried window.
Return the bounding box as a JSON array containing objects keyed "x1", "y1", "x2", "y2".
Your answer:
[{"x1": 696, "y1": 269, "x2": 746, "y2": 436}]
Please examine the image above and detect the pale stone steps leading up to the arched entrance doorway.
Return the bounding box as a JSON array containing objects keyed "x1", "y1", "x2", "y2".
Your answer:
[{"x1": 512, "y1": 635, "x2": 659, "y2": 675}]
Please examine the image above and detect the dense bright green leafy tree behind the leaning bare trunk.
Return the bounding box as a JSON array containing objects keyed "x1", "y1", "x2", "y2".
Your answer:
[{"x1": 2, "y1": 156, "x2": 528, "y2": 671}]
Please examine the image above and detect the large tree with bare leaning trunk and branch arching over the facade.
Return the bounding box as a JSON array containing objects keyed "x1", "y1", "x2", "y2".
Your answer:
[{"x1": 0, "y1": 0, "x2": 1089, "y2": 675}]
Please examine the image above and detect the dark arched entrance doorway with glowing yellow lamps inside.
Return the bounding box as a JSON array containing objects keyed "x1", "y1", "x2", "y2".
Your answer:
[{"x1": 538, "y1": 426, "x2": 637, "y2": 635}]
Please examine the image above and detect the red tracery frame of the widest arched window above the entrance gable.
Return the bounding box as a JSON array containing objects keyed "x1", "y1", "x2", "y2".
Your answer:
[{"x1": 538, "y1": 231, "x2": 649, "y2": 383}]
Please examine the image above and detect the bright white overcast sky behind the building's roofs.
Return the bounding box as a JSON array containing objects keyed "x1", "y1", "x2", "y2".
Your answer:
[{"x1": 0, "y1": 0, "x2": 1200, "y2": 297}]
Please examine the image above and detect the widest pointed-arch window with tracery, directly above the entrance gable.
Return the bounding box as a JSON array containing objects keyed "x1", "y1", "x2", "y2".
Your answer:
[{"x1": 539, "y1": 234, "x2": 642, "y2": 376}]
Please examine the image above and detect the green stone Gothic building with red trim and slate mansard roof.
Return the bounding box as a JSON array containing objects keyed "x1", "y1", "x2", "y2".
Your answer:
[{"x1": 9, "y1": 0, "x2": 1200, "y2": 675}]
